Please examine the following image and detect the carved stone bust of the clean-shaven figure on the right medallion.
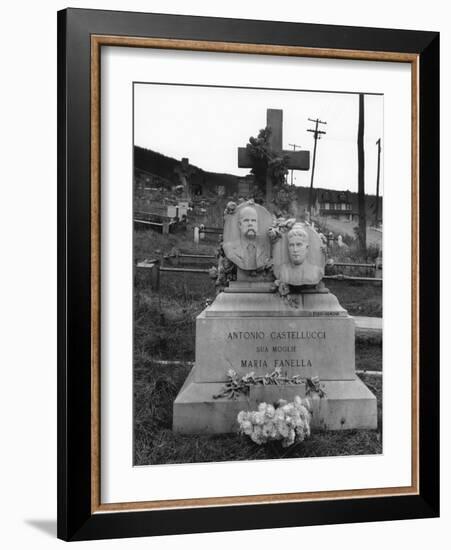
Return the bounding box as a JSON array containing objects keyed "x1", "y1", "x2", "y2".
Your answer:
[{"x1": 279, "y1": 223, "x2": 324, "y2": 286}]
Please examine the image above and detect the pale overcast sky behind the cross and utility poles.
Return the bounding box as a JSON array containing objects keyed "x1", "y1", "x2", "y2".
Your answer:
[{"x1": 134, "y1": 83, "x2": 383, "y2": 194}]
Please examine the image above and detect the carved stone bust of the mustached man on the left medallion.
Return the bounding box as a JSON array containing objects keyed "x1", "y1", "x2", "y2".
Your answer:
[{"x1": 223, "y1": 205, "x2": 269, "y2": 270}]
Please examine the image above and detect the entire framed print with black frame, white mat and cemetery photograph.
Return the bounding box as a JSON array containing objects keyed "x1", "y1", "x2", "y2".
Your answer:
[{"x1": 58, "y1": 9, "x2": 439, "y2": 540}]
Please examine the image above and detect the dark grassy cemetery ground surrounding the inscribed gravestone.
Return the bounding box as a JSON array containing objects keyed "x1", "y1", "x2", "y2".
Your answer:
[{"x1": 134, "y1": 230, "x2": 382, "y2": 465}]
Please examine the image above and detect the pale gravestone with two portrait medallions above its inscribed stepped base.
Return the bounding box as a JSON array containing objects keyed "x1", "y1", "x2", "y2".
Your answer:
[{"x1": 173, "y1": 202, "x2": 377, "y2": 434}]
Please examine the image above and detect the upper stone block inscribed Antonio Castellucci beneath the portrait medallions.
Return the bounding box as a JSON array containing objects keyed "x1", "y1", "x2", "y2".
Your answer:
[{"x1": 195, "y1": 294, "x2": 355, "y2": 383}]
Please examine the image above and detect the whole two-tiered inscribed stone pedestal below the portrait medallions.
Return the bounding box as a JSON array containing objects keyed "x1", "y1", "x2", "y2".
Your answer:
[{"x1": 173, "y1": 288, "x2": 377, "y2": 440}]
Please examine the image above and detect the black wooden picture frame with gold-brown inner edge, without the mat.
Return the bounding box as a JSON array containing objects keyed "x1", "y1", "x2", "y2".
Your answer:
[{"x1": 58, "y1": 9, "x2": 439, "y2": 540}]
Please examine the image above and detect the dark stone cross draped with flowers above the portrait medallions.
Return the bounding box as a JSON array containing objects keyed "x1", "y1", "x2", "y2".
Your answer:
[{"x1": 238, "y1": 109, "x2": 310, "y2": 206}]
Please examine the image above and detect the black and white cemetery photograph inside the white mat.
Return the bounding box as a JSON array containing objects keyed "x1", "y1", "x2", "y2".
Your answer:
[{"x1": 130, "y1": 82, "x2": 384, "y2": 466}]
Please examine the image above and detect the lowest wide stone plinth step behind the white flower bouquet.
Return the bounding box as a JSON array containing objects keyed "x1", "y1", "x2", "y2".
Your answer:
[{"x1": 173, "y1": 367, "x2": 377, "y2": 434}]
